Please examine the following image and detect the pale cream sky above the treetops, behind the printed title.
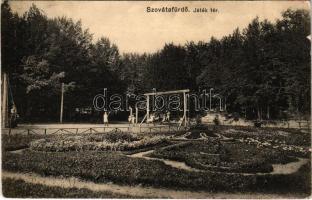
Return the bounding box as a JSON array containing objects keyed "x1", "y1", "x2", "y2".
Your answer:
[{"x1": 10, "y1": 1, "x2": 310, "y2": 53}]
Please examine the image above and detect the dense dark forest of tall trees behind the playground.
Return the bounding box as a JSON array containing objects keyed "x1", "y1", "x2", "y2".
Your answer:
[{"x1": 1, "y1": 1, "x2": 310, "y2": 121}]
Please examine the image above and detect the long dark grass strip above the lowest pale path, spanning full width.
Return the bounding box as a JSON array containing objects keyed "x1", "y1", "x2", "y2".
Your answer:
[{"x1": 3, "y1": 150, "x2": 310, "y2": 193}]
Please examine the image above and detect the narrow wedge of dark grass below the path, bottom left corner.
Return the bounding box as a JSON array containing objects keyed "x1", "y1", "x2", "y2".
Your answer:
[{"x1": 2, "y1": 178, "x2": 140, "y2": 199}]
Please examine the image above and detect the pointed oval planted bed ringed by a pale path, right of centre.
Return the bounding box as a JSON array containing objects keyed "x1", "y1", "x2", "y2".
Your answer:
[{"x1": 149, "y1": 140, "x2": 297, "y2": 173}]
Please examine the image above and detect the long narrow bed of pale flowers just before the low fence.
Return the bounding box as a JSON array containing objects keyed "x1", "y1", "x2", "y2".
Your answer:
[{"x1": 30, "y1": 132, "x2": 166, "y2": 152}]
